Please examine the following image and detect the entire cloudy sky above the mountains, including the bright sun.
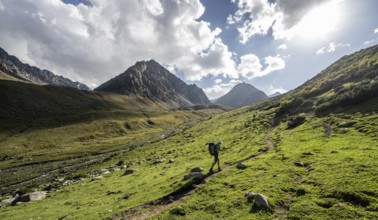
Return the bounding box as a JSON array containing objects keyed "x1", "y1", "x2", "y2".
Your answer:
[{"x1": 0, "y1": 0, "x2": 378, "y2": 99}]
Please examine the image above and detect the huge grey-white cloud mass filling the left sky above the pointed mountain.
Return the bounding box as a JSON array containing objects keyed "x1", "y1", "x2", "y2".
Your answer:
[{"x1": 0, "y1": 0, "x2": 238, "y2": 87}]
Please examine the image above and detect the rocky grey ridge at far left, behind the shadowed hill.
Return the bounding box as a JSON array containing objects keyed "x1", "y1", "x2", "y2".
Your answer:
[{"x1": 0, "y1": 48, "x2": 90, "y2": 90}]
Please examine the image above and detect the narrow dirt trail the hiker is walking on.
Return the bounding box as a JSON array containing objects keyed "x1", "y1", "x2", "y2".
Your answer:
[{"x1": 108, "y1": 126, "x2": 275, "y2": 220}]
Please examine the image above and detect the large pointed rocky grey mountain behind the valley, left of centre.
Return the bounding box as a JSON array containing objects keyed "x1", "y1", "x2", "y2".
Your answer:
[{"x1": 95, "y1": 60, "x2": 211, "y2": 107}]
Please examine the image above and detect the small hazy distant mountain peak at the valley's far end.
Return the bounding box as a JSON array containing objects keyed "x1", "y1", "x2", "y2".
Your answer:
[{"x1": 216, "y1": 83, "x2": 268, "y2": 108}]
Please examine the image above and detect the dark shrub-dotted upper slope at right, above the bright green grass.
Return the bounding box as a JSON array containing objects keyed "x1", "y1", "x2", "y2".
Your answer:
[{"x1": 265, "y1": 45, "x2": 378, "y2": 117}]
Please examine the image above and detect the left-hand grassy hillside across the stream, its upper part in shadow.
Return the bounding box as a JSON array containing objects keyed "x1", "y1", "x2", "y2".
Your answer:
[{"x1": 0, "y1": 81, "x2": 222, "y2": 192}]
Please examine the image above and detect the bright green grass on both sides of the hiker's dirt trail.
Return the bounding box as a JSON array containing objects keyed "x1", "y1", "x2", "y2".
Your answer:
[{"x1": 0, "y1": 102, "x2": 378, "y2": 219}]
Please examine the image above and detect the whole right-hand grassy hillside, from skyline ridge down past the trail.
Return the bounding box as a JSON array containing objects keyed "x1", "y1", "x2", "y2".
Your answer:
[{"x1": 0, "y1": 44, "x2": 378, "y2": 219}]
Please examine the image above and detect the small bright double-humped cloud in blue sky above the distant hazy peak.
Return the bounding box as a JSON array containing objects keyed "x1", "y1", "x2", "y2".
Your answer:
[{"x1": 237, "y1": 54, "x2": 285, "y2": 79}]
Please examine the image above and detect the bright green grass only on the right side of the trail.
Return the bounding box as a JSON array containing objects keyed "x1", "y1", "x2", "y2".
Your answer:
[{"x1": 154, "y1": 114, "x2": 378, "y2": 219}]
